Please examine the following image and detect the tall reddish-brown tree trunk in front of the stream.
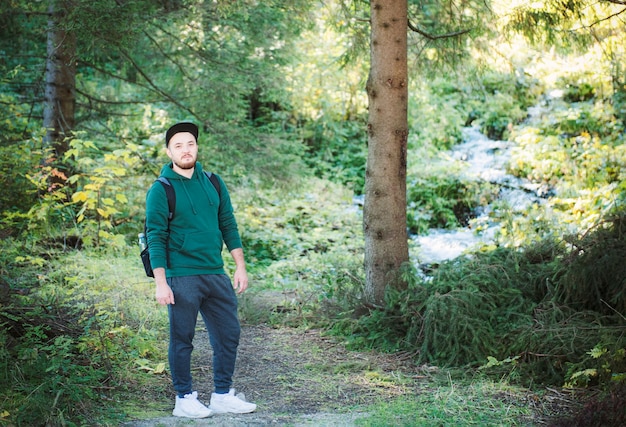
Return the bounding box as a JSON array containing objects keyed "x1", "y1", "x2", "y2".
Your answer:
[{"x1": 363, "y1": 0, "x2": 409, "y2": 305}]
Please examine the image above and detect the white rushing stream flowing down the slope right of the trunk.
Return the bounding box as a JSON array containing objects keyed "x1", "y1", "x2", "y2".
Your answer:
[{"x1": 411, "y1": 123, "x2": 546, "y2": 265}]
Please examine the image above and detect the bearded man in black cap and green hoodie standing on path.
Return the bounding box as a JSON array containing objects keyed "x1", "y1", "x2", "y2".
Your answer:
[{"x1": 146, "y1": 122, "x2": 256, "y2": 418}]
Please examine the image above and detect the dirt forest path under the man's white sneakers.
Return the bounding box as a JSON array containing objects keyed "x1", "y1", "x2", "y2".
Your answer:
[{"x1": 124, "y1": 324, "x2": 412, "y2": 427}]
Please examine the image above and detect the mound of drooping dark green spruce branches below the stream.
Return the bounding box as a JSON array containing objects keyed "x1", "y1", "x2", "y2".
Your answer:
[{"x1": 324, "y1": 209, "x2": 626, "y2": 385}]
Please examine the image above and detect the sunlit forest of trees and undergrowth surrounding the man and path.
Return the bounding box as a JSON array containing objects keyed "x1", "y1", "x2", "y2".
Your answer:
[{"x1": 0, "y1": 0, "x2": 626, "y2": 426}]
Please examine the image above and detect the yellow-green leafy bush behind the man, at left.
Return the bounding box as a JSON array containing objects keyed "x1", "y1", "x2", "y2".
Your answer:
[{"x1": 4, "y1": 135, "x2": 149, "y2": 249}]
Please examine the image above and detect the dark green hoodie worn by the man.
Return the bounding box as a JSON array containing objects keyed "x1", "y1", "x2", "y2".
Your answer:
[{"x1": 146, "y1": 163, "x2": 242, "y2": 277}]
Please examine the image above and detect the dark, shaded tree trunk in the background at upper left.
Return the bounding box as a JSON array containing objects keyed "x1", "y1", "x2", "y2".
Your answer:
[{"x1": 43, "y1": 0, "x2": 76, "y2": 184}]
